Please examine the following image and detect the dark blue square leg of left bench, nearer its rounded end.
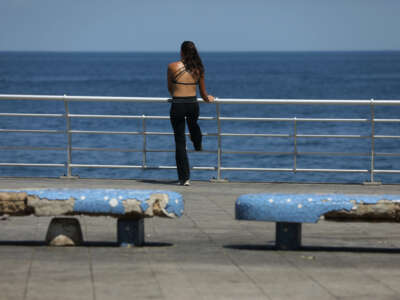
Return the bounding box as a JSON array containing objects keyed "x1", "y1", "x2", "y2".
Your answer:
[{"x1": 117, "y1": 218, "x2": 144, "y2": 247}]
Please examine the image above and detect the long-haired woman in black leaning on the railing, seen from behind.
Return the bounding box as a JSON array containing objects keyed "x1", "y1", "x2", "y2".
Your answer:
[{"x1": 167, "y1": 41, "x2": 214, "y2": 186}]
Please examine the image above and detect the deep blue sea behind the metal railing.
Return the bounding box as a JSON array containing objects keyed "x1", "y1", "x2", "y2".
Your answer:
[{"x1": 0, "y1": 51, "x2": 400, "y2": 184}]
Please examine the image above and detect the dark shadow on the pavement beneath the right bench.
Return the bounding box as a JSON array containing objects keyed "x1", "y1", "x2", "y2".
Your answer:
[{"x1": 223, "y1": 244, "x2": 400, "y2": 254}]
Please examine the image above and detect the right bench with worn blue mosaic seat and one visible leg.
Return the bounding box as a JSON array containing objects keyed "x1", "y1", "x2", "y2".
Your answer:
[{"x1": 235, "y1": 194, "x2": 400, "y2": 250}]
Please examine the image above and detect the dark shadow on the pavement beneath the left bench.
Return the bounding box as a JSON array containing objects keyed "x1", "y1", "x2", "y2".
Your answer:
[{"x1": 0, "y1": 241, "x2": 174, "y2": 248}]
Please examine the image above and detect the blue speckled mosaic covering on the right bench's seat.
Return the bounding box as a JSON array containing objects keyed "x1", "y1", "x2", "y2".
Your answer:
[{"x1": 235, "y1": 194, "x2": 400, "y2": 223}]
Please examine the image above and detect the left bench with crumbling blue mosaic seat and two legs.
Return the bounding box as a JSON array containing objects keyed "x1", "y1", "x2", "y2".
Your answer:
[{"x1": 0, "y1": 188, "x2": 183, "y2": 246}]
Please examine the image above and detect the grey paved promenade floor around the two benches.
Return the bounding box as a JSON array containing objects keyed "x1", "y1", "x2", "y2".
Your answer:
[{"x1": 0, "y1": 178, "x2": 400, "y2": 300}]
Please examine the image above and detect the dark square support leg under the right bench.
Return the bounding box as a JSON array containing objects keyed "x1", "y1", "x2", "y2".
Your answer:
[{"x1": 276, "y1": 222, "x2": 301, "y2": 250}]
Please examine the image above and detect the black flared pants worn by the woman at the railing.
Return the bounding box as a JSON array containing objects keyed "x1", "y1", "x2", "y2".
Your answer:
[{"x1": 170, "y1": 102, "x2": 202, "y2": 181}]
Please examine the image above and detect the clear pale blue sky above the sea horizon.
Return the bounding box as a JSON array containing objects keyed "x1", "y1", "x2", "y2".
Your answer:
[{"x1": 0, "y1": 0, "x2": 400, "y2": 51}]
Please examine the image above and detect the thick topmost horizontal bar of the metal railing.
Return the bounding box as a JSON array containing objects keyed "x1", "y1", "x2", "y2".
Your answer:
[{"x1": 0, "y1": 94, "x2": 400, "y2": 105}]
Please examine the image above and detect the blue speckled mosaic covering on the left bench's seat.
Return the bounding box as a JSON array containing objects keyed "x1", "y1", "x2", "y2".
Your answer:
[{"x1": 0, "y1": 188, "x2": 184, "y2": 217}]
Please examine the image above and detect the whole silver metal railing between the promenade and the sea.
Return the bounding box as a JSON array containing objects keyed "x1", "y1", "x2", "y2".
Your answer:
[{"x1": 0, "y1": 95, "x2": 400, "y2": 182}]
